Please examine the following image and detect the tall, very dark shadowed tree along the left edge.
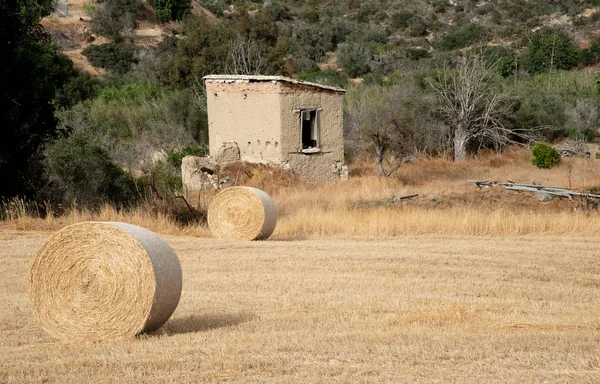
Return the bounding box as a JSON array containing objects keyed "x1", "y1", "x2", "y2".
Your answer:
[{"x1": 0, "y1": 0, "x2": 74, "y2": 198}]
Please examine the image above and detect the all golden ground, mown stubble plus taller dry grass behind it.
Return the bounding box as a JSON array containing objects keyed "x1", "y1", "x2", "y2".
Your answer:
[{"x1": 0, "y1": 151, "x2": 600, "y2": 383}]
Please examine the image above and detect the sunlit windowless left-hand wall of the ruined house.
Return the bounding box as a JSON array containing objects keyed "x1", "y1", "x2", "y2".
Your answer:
[{"x1": 205, "y1": 80, "x2": 282, "y2": 164}]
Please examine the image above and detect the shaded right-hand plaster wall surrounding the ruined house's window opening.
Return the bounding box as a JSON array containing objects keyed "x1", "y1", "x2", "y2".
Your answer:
[{"x1": 281, "y1": 84, "x2": 344, "y2": 180}]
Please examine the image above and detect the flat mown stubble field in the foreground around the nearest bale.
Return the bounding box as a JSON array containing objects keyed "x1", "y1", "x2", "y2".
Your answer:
[{"x1": 0, "y1": 230, "x2": 600, "y2": 383}]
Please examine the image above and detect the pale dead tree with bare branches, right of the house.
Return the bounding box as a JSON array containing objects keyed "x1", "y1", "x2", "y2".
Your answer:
[{"x1": 429, "y1": 54, "x2": 514, "y2": 161}]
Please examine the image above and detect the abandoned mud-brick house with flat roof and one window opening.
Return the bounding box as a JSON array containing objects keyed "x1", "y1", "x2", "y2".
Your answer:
[{"x1": 204, "y1": 75, "x2": 347, "y2": 180}]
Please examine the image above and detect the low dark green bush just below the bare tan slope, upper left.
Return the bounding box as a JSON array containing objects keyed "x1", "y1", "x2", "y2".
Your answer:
[{"x1": 81, "y1": 43, "x2": 136, "y2": 74}]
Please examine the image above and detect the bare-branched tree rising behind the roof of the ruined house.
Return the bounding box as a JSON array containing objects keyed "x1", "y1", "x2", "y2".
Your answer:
[{"x1": 225, "y1": 35, "x2": 269, "y2": 75}]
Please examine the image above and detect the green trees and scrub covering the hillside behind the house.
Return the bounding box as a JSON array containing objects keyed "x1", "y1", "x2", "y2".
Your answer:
[{"x1": 0, "y1": 0, "x2": 600, "y2": 222}]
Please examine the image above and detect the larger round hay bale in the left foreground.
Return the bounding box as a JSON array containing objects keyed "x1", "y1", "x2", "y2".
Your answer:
[{"x1": 29, "y1": 222, "x2": 182, "y2": 341}]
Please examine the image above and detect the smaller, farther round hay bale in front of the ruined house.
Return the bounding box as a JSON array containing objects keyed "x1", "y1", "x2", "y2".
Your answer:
[{"x1": 208, "y1": 187, "x2": 277, "y2": 240}]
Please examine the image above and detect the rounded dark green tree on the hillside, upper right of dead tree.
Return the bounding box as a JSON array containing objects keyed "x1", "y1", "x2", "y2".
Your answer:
[{"x1": 527, "y1": 28, "x2": 581, "y2": 74}]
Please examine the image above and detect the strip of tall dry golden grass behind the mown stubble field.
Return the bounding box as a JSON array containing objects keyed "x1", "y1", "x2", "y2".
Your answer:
[{"x1": 0, "y1": 150, "x2": 600, "y2": 240}]
